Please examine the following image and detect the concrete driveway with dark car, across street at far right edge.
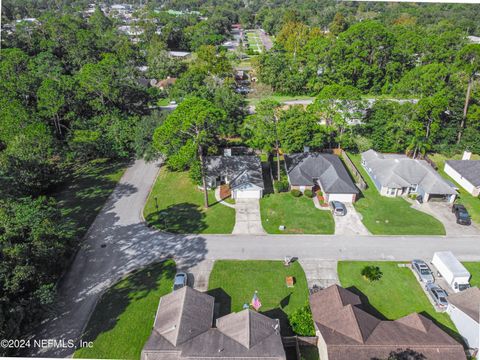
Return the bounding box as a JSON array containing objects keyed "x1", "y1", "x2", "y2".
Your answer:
[{"x1": 412, "y1": 202, "x2": 480, "y2": 235}]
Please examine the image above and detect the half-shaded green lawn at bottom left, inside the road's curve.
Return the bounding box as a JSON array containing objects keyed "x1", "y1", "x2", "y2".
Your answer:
[{"x1": 74, "y1": 260, "x2": 175, "y2": 360}]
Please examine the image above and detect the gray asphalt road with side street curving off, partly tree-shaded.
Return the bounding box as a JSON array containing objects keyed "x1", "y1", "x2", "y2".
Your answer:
[{"x1": 33, "y1": 160, "x2": 480, "y2": 357}]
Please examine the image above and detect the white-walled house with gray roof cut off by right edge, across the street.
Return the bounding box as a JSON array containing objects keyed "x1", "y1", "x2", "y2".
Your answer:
[{"x1": 444, "y1": 160, "x2": 480, "y2": 196}]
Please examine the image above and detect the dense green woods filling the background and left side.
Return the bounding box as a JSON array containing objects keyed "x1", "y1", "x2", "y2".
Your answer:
[{"x1": 0, "y1": 0, "x2": 480, "y2": 354}]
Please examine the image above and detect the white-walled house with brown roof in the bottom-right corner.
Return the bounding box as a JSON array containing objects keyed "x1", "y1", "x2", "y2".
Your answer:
[{"x1": 447, "y1": 287, "x2": 480, "y2": 358}]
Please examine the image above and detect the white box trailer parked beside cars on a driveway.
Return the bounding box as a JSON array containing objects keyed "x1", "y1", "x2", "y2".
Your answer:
[{"x1": 432, "y1": 251, "x2": 470, "y2": 292}]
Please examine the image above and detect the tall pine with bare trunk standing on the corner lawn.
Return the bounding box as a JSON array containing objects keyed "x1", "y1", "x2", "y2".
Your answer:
[{"x1": 153, "y1": 97, "x2": 226, "y2": 208}]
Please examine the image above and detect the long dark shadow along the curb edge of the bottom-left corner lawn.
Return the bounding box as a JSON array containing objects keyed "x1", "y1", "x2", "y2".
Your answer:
[{"x1": 82, "y1": 260, "x2": 175, "y2": 341}]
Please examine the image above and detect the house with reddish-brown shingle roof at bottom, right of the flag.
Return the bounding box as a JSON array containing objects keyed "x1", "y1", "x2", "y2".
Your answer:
[{"x1": 310, "y1": 285, "x2": 466, "y2": 360}]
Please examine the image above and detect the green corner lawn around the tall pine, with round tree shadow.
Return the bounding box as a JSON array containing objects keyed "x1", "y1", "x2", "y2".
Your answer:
[{"x1": 143, "y1": 168, "x2": 235, "y2": 234}]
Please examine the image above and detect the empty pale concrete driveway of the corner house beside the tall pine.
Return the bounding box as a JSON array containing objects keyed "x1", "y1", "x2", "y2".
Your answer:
[{"x1": 232, "y1": 199, "x2": 266, "y2": 235}]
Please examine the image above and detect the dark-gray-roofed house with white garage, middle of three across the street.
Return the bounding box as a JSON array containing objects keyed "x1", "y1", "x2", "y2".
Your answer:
[{"x1": 285, "y1": 152, "x2": 359, "y2": 203}]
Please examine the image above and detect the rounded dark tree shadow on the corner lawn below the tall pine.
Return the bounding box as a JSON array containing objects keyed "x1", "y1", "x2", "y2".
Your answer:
[{"x1": 146, "y1": 203, "x2": 207, "y2": 234}]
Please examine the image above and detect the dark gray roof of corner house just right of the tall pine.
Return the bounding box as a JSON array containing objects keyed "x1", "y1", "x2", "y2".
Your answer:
[{"x1": 205, "y1": 155, "x2": 265, "y2": 189}]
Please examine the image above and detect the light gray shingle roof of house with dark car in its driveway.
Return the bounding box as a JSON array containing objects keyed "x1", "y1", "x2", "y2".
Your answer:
[{"x1": 362, "y1": 150, "x2": 457, "y2": 195}]
